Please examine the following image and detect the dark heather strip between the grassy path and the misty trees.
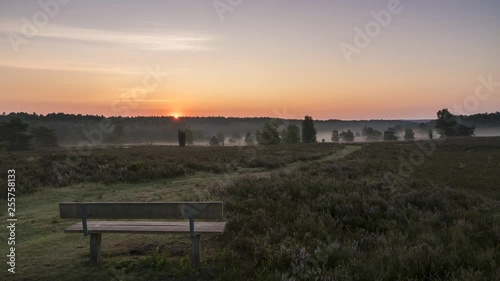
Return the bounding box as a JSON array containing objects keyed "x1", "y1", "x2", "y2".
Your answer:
[{"x1": 0, "y1": 145, "x2": 340, "y2": 198}]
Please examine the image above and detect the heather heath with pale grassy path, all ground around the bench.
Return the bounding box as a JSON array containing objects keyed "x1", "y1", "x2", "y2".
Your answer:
[{"x1": 0, "y1": 138, "x2": 500, "y2": 280}]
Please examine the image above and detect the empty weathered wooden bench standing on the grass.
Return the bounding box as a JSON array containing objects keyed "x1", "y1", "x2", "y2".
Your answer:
[{"x1": 59, "y1": 202, "x2": 226, "y2": 266}]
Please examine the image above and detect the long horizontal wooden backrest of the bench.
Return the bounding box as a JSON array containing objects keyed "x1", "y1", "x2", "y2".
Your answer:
[{"x1": 59, "y1": 202, "x2": 223, "y2": 220}]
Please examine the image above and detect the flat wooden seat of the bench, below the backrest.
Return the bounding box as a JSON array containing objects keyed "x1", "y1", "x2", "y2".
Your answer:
[{"x1": 64, "y1": 221, "x2": 226, "y2": 234}]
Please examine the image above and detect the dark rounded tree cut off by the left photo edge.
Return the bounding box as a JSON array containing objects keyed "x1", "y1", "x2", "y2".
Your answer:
[{"x1": 0, "y1": 118, "x2": 33, "y2": 150}]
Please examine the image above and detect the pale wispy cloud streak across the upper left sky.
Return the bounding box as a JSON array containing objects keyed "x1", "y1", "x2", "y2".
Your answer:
[{"x1": 0, "y1": 19, "x2": 215, "y2": 75}]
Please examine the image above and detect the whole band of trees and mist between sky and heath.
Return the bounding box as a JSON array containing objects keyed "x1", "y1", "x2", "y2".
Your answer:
[{"x1": 0, "y1": 109, "x2": 484, "y2": 150}]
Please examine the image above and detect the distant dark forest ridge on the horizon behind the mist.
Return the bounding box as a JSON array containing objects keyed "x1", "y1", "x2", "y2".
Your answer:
[{"x1": 0, "y1": 112, "x2": 500, "y2": 145}]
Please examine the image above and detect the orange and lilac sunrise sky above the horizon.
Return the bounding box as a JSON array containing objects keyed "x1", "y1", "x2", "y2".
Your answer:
[{"x1": 0, "y1": 0, "x2": 500, "y2": 120}]
